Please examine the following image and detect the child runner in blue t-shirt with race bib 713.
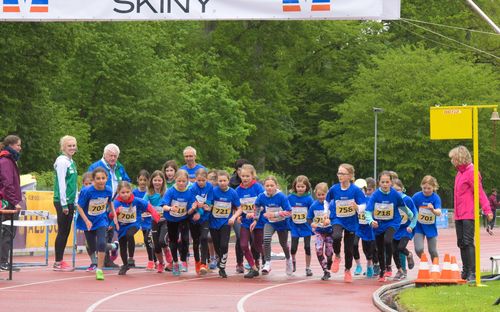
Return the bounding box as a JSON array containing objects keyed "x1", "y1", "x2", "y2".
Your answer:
[{"x1": 288, "y1": 175, "x2": 314, "y2": 276}]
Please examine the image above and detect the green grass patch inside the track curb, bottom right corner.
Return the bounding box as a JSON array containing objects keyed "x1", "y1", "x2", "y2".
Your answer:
[{"x1": 397, "y1": 281, "x2": 500, "y2": 312}]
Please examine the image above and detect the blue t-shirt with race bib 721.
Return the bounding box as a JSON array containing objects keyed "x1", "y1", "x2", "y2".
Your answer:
[{"x1": 210, "y1": 186, "x2": 241, "y2": 230}]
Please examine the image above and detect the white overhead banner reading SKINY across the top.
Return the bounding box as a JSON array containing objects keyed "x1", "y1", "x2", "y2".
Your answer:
[{"x1": 0, "y1": 0, "x2": 401, "y2": 21}]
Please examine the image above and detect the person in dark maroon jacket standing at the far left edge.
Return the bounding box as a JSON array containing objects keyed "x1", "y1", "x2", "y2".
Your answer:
[{"x1": 0, "y1": 135, "x2": 22, "y2": 270}]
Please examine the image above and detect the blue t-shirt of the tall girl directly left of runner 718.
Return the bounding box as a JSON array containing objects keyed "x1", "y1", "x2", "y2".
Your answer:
[{"x1": 326, "y1": 183, "x2": 366, "y2": 233}]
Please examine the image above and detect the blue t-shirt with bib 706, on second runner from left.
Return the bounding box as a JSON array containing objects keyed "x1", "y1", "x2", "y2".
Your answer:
[{"x1": 114, "y1": 196, "x2": 151, "y2": 238}]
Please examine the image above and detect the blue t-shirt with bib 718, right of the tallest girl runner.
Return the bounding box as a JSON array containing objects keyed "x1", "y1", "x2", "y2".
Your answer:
[{"x1": 366, "y1": 187, "x2": 405, "y2": 235}]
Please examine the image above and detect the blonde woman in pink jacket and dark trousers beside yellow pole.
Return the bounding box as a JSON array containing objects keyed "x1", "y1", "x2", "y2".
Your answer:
[{"x1": 448, "y1": 146, "x2": 493, "y2": 280}]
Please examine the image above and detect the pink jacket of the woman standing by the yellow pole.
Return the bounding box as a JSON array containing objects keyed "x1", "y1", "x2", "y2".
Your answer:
[{"x1": 453, "y1": 164, "x2": 491, "y2": 220}]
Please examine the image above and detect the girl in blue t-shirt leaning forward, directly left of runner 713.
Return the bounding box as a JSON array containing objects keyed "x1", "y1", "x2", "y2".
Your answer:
[{"x1": 254, "y1": 176, "x2": 293, "y2": 276}]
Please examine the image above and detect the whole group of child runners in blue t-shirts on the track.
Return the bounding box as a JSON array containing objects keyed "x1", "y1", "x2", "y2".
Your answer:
[{"x1": 71, "y1": 161, "x2": 441, "y2": 283}]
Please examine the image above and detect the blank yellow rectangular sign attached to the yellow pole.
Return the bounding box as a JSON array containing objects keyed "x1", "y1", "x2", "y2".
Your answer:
[{"x1": 430, "y1": 106, "x2": 472, "y2": 140}]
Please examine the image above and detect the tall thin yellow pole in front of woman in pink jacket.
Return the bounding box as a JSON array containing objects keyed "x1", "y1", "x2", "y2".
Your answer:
[{"x1": 472, "y1": 106, "x2": 482, "y2": 286}]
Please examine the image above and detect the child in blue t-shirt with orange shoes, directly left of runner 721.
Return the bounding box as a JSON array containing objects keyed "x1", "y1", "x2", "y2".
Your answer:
[{"x1": 188, "y1": 168, "x2": 214, "y2": 275}]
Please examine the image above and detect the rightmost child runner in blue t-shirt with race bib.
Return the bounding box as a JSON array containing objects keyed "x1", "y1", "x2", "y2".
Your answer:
[{"x1": 412, "y1": 175, "x2": 441, "y2": 259}]
